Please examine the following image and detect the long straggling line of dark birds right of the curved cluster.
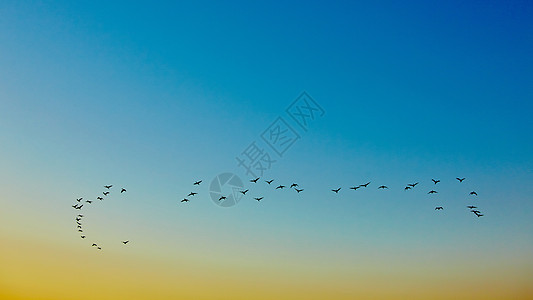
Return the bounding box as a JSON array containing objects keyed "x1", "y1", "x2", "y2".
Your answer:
[{"x1": 181, "y1": 177, "x2": 483, "y2": 218}]
